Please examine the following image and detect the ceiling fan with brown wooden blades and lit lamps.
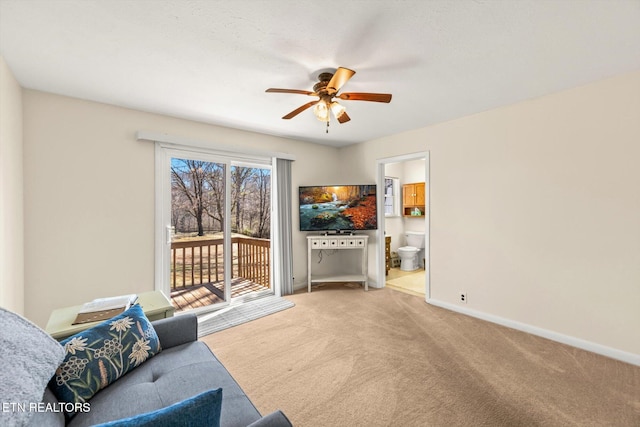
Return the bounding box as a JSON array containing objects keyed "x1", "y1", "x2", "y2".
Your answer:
[{"x1": 266, "y1": 67, "x2": 391, "y2": 133}]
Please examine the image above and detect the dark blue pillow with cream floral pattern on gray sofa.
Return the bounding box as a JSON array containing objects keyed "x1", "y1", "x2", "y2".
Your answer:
[{"x1": 49, "y1": 304, "x2": 162, "y2": 417}]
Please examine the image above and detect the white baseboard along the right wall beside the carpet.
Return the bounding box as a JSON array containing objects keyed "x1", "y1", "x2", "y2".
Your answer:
[{"x1": 426, "y1": 299, "x2": 640, "y2": 366}]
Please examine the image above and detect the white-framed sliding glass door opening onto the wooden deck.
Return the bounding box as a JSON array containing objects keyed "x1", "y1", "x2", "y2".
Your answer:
[{"x1": 156, "y1": 148, "x2": 273, "y2": 311}]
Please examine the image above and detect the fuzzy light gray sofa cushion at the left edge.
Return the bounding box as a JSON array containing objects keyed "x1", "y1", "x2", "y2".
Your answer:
[{"x1": 0, "y1": 307, "x2": 64, "y2": 425}]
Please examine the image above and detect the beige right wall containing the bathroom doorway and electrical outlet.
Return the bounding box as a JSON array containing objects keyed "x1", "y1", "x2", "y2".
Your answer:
[{"x1": 340, "y1": 72, "x2": 640, "y2": 355}]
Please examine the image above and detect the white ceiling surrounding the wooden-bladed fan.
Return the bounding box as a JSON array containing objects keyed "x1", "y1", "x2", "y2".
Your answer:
[{"x1": 0, "y1": 0, "x2": 640, "y2": 146}]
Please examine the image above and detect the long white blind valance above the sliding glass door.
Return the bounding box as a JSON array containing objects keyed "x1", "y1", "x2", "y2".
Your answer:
[{"x1": 136, "y1": 130, "x2": 296, "y2": 161}]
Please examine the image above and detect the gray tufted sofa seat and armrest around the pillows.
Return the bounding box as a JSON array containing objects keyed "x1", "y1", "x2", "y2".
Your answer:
[{"x1": 20, "y1": 315, "x2": 291, "y2": 427}]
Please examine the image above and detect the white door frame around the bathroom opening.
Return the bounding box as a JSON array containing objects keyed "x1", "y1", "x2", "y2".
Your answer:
[{"x1": 376, "y1": 151, "x2": 431, "y2": 302}]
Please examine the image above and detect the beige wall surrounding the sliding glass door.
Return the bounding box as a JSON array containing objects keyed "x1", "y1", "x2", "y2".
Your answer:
[{"x1": 24, "y1": 90, "x2": 337, "y2": 325}]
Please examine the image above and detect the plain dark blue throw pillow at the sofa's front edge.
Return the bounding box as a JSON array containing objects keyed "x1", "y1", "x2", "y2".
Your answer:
[{"x1": 94, "y1": 388, "x2": 222, "y2": 427}]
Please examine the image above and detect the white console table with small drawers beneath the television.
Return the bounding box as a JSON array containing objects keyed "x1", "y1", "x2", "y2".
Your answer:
[{"x1": 307, "y1": 234, "x2": 369, "y2": 292}]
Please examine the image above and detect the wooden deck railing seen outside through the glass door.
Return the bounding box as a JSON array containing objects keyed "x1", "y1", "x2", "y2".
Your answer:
[{"x1": 171, "y1": 236, "x2": 271, "y2": 290}]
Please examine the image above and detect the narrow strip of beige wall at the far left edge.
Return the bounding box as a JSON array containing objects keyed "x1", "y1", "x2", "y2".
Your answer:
[{"x1": 0, "y1": 56, "x2": 24, "y2": 314}]
